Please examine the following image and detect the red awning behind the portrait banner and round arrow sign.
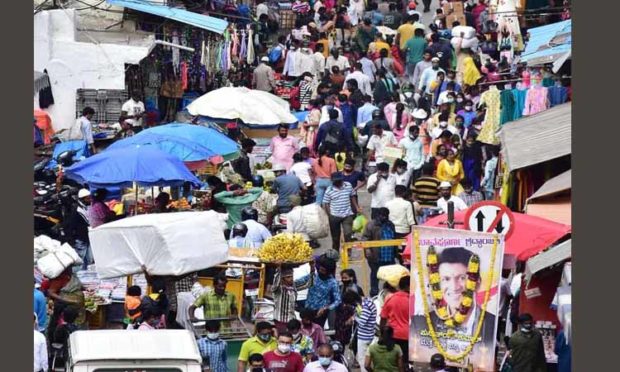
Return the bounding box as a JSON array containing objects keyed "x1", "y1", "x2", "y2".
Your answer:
[{"x1": 403, "y1": 211, "x2": 571, "y2": 261}]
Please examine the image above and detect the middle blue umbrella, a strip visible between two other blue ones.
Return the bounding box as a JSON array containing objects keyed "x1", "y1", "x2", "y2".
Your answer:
[{"x1": 106, "y1": 130, "x2": 218, "y2": 161}]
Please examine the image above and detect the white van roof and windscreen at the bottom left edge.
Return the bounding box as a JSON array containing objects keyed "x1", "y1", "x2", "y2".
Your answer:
[{"x1": 66, "y1": 329, "x2": 202, "y2": 372}]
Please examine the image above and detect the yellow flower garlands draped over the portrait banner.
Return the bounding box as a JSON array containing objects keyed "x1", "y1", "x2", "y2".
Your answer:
[{"x1": 414, "y1": 231, "x2": 497, "y2": 362}]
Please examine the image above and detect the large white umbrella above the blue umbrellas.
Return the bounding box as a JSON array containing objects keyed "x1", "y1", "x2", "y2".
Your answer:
[{"x1": 187, "y1": 87, "x2": 297, "y2": 125}]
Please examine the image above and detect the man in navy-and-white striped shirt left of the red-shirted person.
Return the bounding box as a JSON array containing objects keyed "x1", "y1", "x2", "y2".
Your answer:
[{"x1": 342, "y1": 291, "x2": 377, "y2": 372}]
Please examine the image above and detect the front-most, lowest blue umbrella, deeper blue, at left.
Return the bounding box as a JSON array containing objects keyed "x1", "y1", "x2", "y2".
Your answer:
[{"x1": 65, "y1": 145, "x2": 200, "y2": 188}]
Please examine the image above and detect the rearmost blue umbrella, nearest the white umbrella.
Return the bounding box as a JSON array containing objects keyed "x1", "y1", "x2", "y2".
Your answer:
[{"x1": 142, "y1": 123, "x2": 239, "y2": 161}]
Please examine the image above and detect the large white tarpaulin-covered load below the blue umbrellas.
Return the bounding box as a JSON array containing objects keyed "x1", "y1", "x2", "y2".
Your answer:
[{"x1": 88, "y1": 211, "x2": 228, "y2": 279}]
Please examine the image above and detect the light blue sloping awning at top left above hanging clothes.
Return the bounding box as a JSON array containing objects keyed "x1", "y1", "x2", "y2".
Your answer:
[{"x1": 106, "y1": 0, "x2": 228, "y2": 34}]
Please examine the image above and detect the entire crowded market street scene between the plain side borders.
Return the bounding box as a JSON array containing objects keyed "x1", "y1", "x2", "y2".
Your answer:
[{"x1": 33, "y1": 0, "x2": 572, "y2": 372}]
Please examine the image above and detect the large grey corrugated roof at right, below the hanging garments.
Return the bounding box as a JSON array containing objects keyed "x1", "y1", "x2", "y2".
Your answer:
[{"x1": 499, "y1": 102, "x2": 572, "y2": 171}]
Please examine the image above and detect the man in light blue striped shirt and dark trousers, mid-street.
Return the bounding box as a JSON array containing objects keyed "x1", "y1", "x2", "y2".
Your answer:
[{"x1": 323, "y1": 172, "x2": 361, "y2": 251}]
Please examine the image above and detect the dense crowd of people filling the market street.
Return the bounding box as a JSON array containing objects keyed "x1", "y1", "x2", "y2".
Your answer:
[{"x1": 35, "y1": 0, "x2": 560, "y2": 372}]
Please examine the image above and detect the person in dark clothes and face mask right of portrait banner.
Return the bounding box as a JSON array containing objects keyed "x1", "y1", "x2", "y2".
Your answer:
[{"x1": 508, "y1": 313, "x2": 547, "y2": 372}]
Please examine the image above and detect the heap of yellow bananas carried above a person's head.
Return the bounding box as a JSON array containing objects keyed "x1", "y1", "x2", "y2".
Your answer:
[{"x1": 258, "y1": 233, "x2": 312, "y2": 263}]
